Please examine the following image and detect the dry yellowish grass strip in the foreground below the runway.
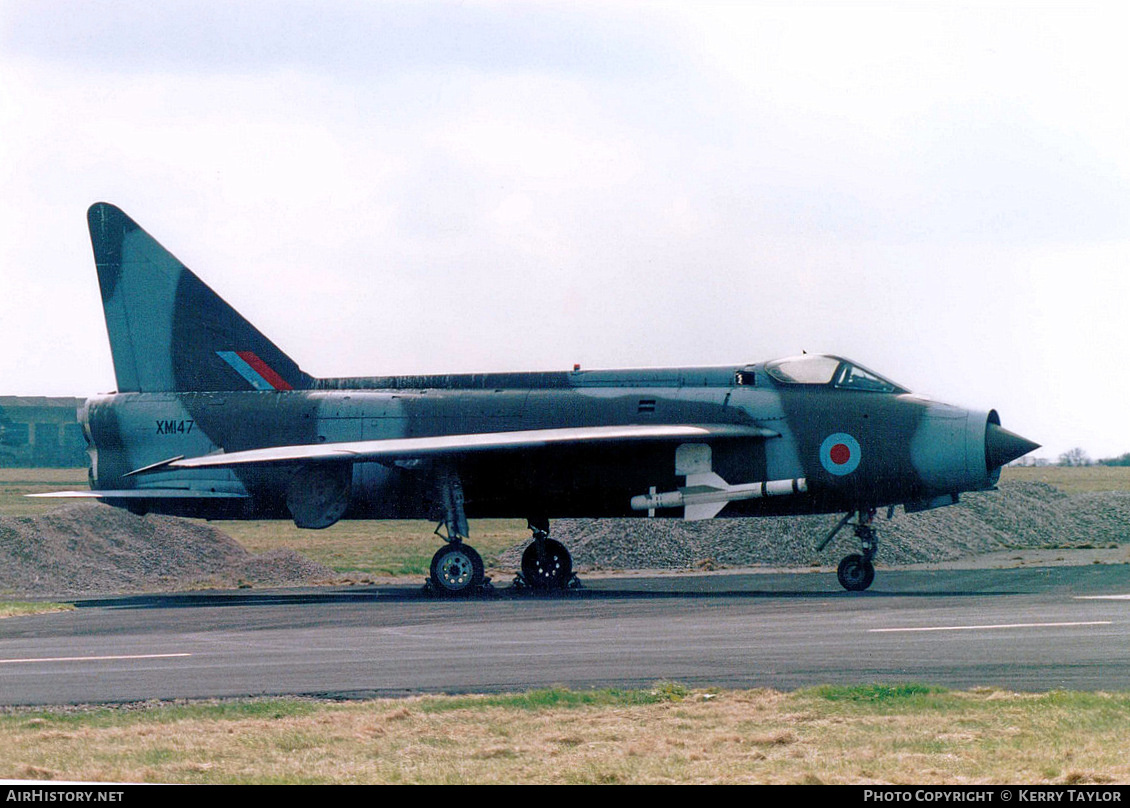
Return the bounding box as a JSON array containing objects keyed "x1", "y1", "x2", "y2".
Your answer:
[{"x1": 0, "y1": 683, "x2": 1130, "y2": 785}]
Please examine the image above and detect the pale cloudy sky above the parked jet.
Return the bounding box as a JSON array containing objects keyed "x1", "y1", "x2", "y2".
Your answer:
[{"x1": 0, "y1": 0, "x2": 1130, "y2": 458}]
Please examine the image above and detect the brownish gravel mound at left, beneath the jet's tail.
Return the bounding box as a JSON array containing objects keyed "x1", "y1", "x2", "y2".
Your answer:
[{"x1": 0, "y1": 504, "x2": 333, "y2": 598}]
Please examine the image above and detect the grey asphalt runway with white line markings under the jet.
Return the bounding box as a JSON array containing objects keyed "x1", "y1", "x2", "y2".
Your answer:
[{"x1": 0, "y1": 565, "x2": 1130, "y2": 705}]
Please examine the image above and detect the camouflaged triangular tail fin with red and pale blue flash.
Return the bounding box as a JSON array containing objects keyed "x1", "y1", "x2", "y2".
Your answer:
[{"x1": 87, "y1": 202, "x2": 313, "y2": 392}]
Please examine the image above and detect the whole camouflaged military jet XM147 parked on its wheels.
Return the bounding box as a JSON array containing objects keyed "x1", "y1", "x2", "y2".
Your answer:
[{"x1": 37, "y1": 202, "x2": 1037, "y2": 596}]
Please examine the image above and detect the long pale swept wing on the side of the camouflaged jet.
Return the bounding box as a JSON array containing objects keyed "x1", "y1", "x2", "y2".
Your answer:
[{"x1": 127, "y1": 424, "x2": 781, "y2": 476}]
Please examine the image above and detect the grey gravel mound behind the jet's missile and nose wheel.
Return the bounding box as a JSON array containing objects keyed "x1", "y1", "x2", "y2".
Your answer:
[{"x1": 501, "y1": 483, "x2": 1130, "y2": 571}]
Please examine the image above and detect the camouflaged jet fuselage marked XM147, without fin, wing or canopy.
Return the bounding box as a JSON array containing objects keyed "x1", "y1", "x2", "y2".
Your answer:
[{"x1": 82, "y1": 365, "x2": 999, "y2": 519}]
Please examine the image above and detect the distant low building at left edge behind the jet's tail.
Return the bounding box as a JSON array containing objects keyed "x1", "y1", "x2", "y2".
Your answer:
[{"x1": 0, "y1": 396, "x2": 87, "y2": 467}]
